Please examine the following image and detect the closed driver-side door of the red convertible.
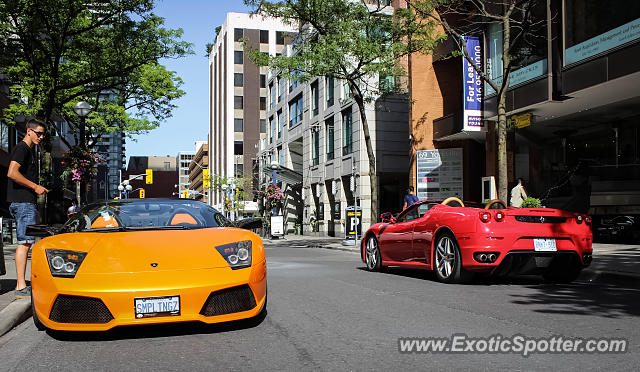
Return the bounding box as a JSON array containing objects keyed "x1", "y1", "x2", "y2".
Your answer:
[{"x1": 378, "y1": 206, "x2": 419, "y2": 262}]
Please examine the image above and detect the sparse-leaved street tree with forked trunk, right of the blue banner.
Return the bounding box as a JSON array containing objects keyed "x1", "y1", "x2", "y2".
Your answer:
[{"x1": 407, "y1": 0, "x2": 546, "y2": 200}]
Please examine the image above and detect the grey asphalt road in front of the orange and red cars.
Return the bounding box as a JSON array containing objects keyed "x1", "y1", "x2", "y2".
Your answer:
[{"x1": 0, "y1": 242, "x2": 640, "y2": 371}]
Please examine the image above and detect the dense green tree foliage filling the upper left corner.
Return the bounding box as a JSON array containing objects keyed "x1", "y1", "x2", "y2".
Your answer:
[{"x1": 0, "y1": 0, "x2": 191, "y2": 141}]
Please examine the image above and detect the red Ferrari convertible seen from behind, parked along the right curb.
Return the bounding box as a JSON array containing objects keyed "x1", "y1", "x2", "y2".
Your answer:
[{"x1": 361, "y1": 198, "x2": 593, "y2": 283}]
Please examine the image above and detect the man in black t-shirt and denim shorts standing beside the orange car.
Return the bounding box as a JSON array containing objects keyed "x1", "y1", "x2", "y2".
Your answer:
[{"x1": 7, "y1": 119, "x2": 49, "y2": 298}]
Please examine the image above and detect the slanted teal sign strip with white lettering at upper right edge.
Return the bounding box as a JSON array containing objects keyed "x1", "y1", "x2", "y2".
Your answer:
[{"x1": 564, "y1": 19, "x2": 640, "y2": 66}]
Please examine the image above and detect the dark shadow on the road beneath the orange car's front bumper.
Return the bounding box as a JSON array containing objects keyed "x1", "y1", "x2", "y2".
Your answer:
[{"x1": 47, "y1": 311, "x2": 267, "y2": 342}]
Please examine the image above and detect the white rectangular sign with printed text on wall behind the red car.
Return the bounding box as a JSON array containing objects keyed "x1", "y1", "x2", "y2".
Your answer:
[{"x1": 416, "y1": 148, "x2": 464, "y2": 200}]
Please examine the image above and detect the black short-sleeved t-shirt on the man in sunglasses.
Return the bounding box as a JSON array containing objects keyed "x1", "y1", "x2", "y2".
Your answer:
[{"x1": 7, "y1": 141, "x2": 38, "y2": 203}]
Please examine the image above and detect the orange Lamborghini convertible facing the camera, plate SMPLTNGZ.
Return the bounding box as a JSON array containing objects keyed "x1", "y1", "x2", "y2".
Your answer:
[{"x1": 29, "y1": 199, "x2": 267, "y2": 331}]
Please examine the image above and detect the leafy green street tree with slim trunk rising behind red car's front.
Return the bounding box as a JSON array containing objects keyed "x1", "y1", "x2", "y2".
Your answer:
[{"x1": 245, "y1": 0, "x2": 443, "y2": 222}]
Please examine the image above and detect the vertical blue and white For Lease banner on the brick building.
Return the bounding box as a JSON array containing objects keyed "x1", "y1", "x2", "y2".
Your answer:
[{"x1": 462, "y1": 36, "x2": 484, "y2": 132}]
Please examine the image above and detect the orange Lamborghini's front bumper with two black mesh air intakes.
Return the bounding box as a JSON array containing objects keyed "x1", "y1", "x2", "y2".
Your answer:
[{"x1": 32, "y1": 261, "x2": 267, "y2": 331}]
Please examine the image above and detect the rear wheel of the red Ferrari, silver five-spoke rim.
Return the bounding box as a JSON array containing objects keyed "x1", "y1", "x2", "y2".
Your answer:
[{"x1": 433, "y1": 233, "x2": 471, "y2": 283}]
